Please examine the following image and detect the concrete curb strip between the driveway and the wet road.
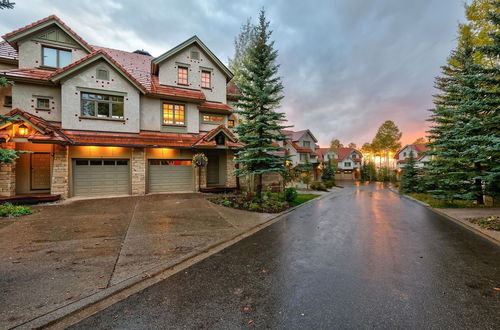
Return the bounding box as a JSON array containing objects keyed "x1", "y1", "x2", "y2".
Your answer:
[{"x1": 16, "y1": 191, "x2": 335, "y2": 329}]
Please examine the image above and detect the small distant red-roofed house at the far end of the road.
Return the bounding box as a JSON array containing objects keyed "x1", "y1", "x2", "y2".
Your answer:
[{"x1": 318, "y1": 148, "x2": 363, "y2": 180}]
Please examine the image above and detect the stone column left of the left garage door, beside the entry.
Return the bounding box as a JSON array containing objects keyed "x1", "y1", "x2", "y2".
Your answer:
[{"x1": 50, "y1": 144, "x2": 69, "y2": 199}]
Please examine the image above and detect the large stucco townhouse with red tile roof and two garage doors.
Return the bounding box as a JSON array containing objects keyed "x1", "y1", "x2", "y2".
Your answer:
[{"x1": 0, "y1": 16, "x2": 239, "y2": 198}]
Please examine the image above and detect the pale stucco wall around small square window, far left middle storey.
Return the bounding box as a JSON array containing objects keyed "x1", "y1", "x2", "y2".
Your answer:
[{"x1": 12, "y1": 83, "x2": 61, "y2": 122}]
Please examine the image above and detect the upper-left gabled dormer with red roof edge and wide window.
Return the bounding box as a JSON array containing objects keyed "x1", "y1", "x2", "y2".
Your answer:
[{"x1": 3, "y1": 16, "x2": 93, "y2": 70}]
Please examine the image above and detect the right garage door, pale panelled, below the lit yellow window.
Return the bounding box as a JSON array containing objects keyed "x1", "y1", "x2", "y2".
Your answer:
[{"x1": 148, "y1": 159, "x2": 194, "y2": 192}]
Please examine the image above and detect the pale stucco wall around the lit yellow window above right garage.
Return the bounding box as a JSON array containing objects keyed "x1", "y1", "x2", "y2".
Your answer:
[{"x1": 140, "y1": 96, "x2": 200, "y2": 133}]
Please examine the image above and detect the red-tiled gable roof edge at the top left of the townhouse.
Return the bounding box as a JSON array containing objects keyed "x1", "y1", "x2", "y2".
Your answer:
[{"x1": 2, "y1": 15, "x2": 94, "y2": 53}]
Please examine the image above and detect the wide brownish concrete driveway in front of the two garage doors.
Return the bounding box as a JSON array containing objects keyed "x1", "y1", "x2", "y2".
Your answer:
[{"x1": 0, "y1": 194, "x2": 271, "y2": 328}]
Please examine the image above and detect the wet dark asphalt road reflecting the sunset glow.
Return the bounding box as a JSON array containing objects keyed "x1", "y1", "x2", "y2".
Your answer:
[{"x1": 74, "y1": 185, "x2": 500, "y2": 329}]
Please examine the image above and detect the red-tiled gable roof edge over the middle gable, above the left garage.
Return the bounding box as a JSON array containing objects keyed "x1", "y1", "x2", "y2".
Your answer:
[{"x1": 50, "y1": 49, "x2": 146, "y2": 93}]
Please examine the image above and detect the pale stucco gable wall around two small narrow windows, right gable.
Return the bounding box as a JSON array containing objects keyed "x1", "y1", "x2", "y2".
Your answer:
[{"x1": 159, "y1": 45, "x2": 226, "y2": 103}]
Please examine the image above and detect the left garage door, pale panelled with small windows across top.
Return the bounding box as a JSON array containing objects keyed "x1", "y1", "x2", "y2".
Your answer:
[{"x1": 73, "y1": 159, "x2": 130, "y2": 196}]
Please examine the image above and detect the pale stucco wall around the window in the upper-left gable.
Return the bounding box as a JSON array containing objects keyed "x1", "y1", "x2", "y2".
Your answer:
[{"x1": 18, "y1": 28, "x2": 87, "y2": 68}]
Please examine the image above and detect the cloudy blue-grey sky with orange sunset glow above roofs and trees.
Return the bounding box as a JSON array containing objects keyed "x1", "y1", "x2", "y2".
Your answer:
[{"x1": 0, "y1": 0, "x2": 463, "y2": 146}]
